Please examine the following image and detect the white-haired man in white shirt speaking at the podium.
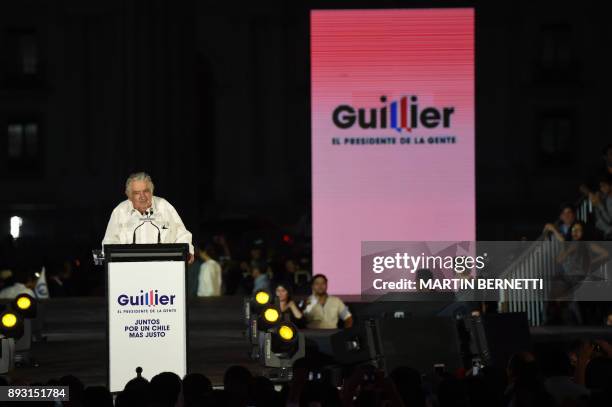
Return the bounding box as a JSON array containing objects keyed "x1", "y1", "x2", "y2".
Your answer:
[{"x1": 102, "y1": 172, "x2": 194, "y2": 264}]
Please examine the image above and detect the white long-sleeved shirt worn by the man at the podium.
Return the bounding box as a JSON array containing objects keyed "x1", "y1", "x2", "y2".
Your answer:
[{"x1": 102, "y1": 196, "x2": 193, "y2": 254}]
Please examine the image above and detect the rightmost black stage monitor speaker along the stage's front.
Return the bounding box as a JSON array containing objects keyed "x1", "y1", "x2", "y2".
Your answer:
[{"x1": 469, "y1": 312, "x2": 532, "y2": 369}]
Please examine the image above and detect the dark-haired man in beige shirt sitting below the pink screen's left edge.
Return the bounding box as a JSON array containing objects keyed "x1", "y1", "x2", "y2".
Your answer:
[{"x1": 304, "y1": 274, "x2": 353, "y2": 329}]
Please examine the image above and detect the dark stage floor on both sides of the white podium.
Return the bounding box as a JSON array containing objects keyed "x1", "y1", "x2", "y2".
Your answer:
[{"x1": 9, "y1": 297, "x2": 261, "y2": 385}]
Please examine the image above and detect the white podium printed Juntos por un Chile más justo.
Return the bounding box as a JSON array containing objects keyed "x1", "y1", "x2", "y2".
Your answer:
[{"x1": 104, "y1": 244, "x2": 189, "y2": 392}]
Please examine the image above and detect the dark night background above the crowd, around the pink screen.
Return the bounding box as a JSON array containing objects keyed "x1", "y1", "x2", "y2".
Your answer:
[{"x1": 0, "y1": 0, "x2": 611, "y2": 268}]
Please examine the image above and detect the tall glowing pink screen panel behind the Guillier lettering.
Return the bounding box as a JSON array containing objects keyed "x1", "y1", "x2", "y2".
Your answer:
[{"x1": 311, "y1": 8, "x2": 476, "y2": 294}]
